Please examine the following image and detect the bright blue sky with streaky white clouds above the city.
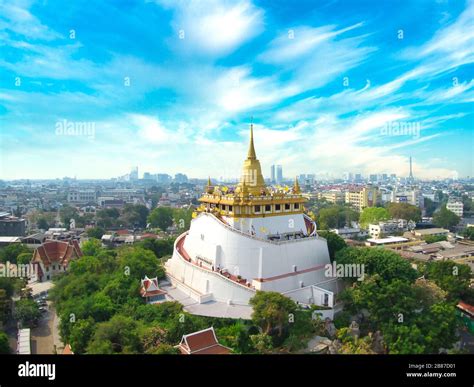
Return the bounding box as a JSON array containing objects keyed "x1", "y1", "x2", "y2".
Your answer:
[{"x1": 0, "y1": 0, "x2": 474, "y2": 179}]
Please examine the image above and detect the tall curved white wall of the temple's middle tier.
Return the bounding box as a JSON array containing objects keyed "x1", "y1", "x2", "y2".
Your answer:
[{"x1": 183, "y1": 213, "x2": 330, "y2": 291}]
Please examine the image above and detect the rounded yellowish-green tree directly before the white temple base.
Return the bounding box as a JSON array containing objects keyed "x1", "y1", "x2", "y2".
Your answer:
[{"x1": 250, "y1": 291, "x2": 296, "y2": 336}]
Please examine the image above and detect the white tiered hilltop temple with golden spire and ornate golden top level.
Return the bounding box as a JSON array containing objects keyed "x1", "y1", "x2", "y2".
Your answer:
[{"x1": 165, "y1": 126, "x2": 338, "y2": 317}]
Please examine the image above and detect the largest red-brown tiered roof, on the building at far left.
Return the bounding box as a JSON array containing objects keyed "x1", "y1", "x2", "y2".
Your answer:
[{"x1": 32, "y1": 239, "x2": 83, "y2": 266}]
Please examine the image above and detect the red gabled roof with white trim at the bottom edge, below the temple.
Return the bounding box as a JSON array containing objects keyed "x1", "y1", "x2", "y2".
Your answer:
[{"x1": 178, "y1": 327, "x2": 231, "y2": 355}]
